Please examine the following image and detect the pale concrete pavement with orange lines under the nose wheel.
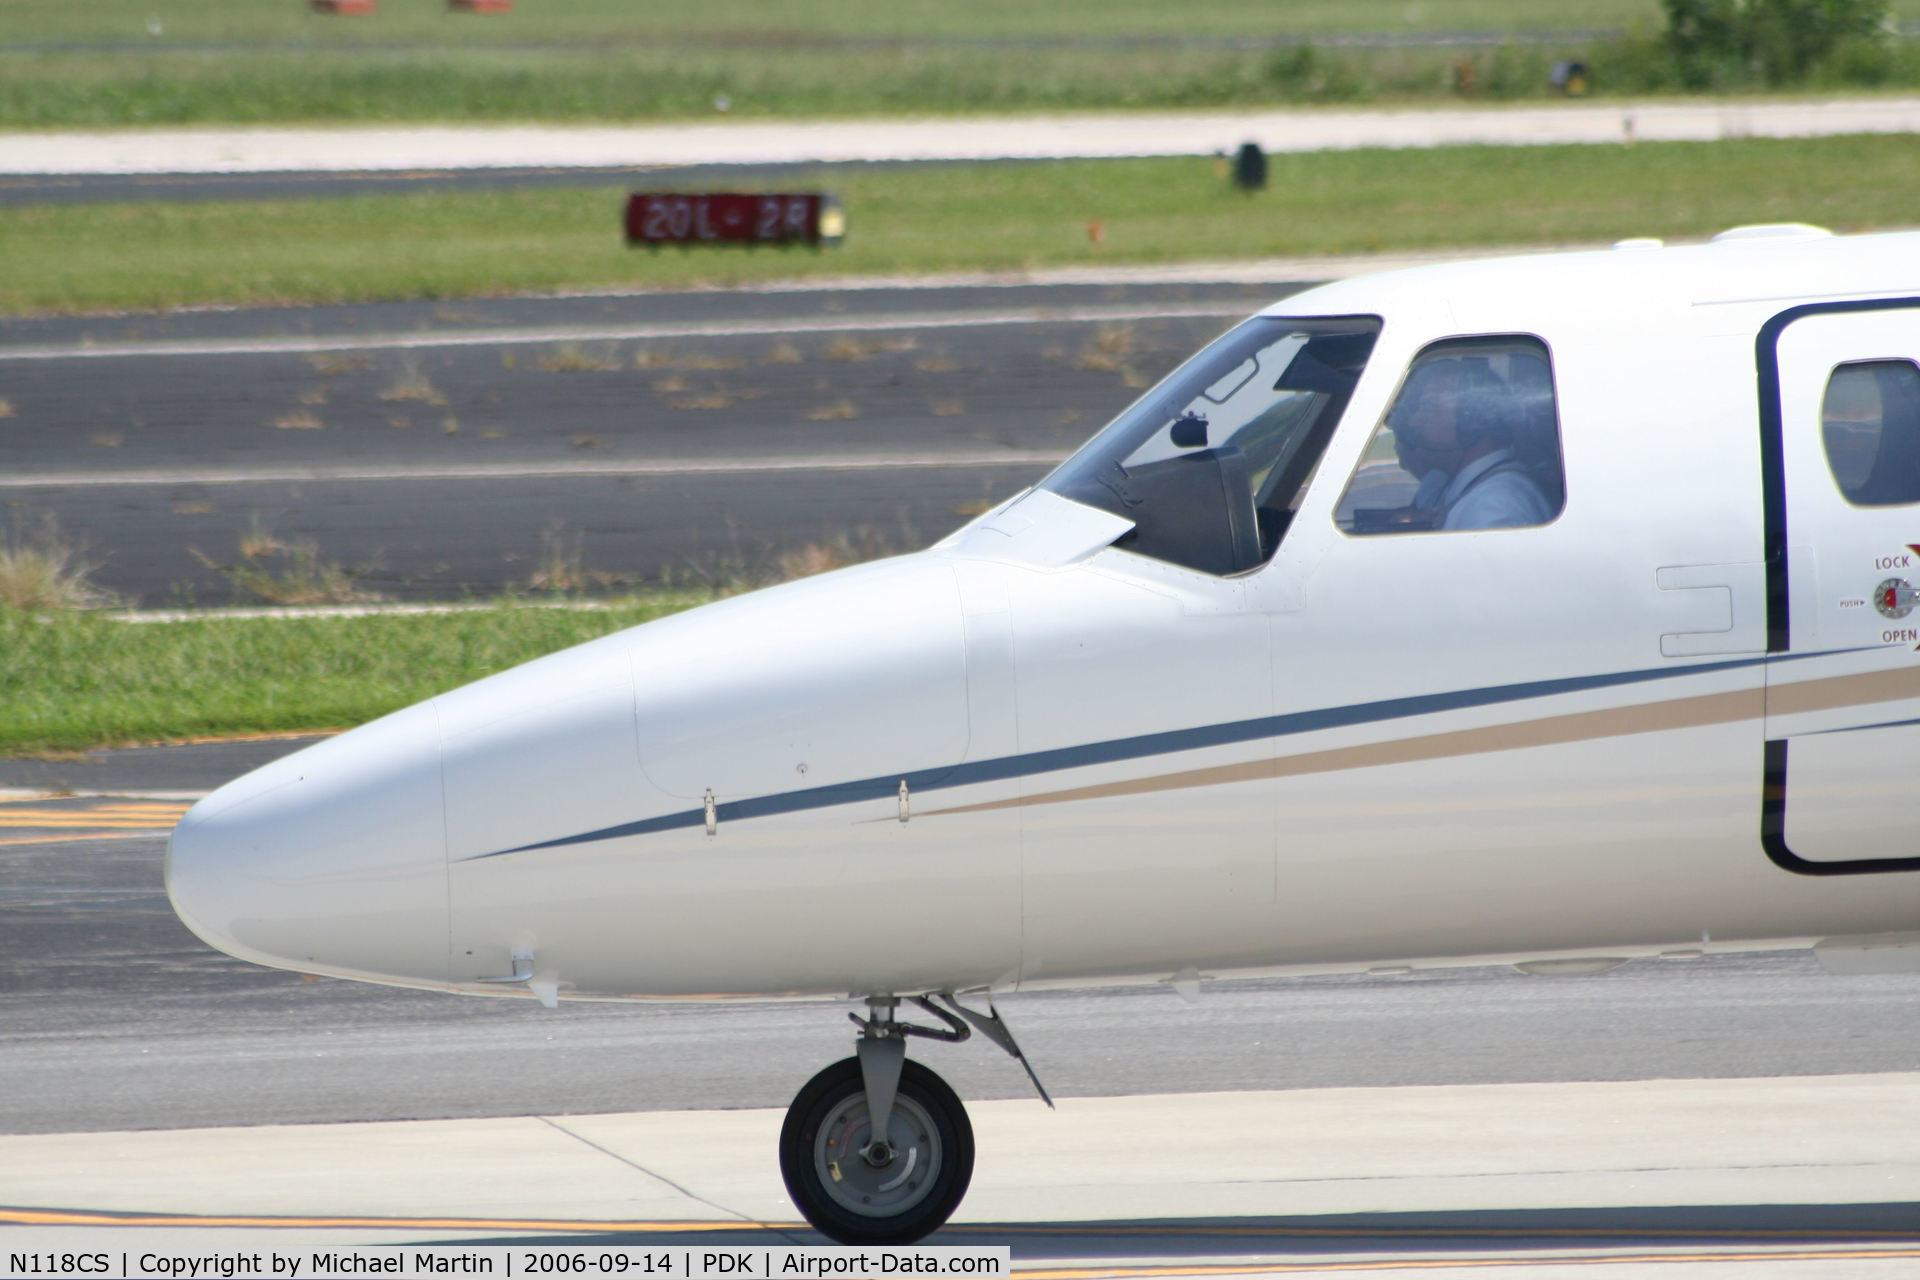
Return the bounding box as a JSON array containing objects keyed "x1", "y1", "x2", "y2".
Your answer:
[{"x1": 0, "y1": 1073, "x2": 1920, "y2": 1276}]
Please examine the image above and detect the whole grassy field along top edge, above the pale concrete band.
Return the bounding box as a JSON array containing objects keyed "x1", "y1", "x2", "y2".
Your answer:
[{"x1": 11, "y1": 0, "x2": 1920, "y2": 127}]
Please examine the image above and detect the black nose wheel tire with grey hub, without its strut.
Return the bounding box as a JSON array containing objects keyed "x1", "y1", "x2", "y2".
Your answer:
[{"x1": 780, "y1": 1057, "x2": 973, "y2": 1244}]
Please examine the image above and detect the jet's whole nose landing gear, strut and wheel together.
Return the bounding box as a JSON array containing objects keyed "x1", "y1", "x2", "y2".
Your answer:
[{"x1": 780, "y1": 992, "x2": 1054, "y2": 1244}]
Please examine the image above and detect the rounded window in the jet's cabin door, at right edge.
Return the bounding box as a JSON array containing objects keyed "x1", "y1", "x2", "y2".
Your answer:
[{"x1": 1820, "y1": 361, "x2": 1920, "y2": 507}]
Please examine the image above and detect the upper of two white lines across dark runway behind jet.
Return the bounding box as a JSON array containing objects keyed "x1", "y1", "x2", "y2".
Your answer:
[{"x1": 0, "y1": 301, "x2": 1258, "y2": 361}]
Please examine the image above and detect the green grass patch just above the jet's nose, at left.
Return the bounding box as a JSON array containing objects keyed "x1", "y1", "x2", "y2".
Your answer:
[{"x1": 0, "y1": 593, "x2": 707, "y2": 756}]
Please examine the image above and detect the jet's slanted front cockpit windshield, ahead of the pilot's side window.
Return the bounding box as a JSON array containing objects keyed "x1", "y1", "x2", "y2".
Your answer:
[{"x1": 1041, "y1": 317, "x2": 1380, "y2": 576}]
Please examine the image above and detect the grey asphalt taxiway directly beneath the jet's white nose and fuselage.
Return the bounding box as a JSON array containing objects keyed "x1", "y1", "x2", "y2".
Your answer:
[{"x1": 0, "y1": 806, "x2": 1920, "y2": 1132}]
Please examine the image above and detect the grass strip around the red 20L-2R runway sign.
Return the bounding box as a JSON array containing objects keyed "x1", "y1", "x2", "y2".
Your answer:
[{"x1": 0, "y1": 136, "x2": 1920, "y2": 315}]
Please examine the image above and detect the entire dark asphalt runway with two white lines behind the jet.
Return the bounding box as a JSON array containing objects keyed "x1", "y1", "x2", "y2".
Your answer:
[{"x1": 0, "y1": 284, "x2": 1292, "y2": 606}]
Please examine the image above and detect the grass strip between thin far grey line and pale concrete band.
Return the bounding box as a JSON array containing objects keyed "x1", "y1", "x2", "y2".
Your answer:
[{"x1": 0, "y1": 42, "x2": 1635, "y2": 129}]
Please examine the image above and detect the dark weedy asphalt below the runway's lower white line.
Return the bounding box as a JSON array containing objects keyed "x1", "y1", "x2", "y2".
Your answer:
[{"x1": 22, "y1": 466, "x2": 1046, "y2": 606}]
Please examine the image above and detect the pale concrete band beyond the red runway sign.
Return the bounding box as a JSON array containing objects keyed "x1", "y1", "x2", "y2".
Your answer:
[{"x1": 11, "y1": 98, "x2": 1920, "y2": 175}]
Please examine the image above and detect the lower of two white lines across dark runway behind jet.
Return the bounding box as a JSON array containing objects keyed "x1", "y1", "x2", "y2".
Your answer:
[{"x1": 0, "y1": 449, "x2": 1066, "y2": 489}]
